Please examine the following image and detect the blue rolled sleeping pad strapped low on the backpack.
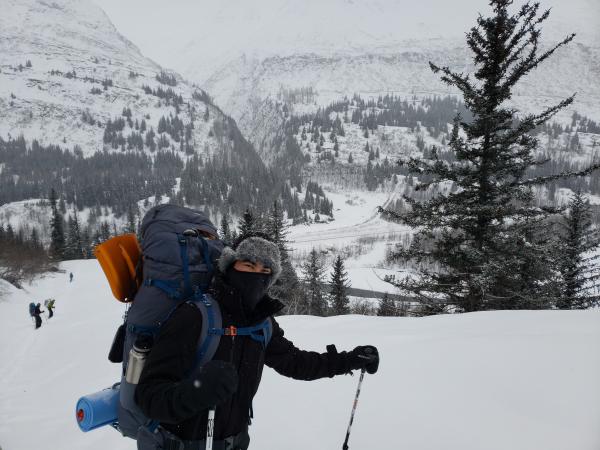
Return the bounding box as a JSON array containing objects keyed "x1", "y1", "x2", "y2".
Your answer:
[{"x1": 75, "y1": 383, "x2": 120, "y2": 432}]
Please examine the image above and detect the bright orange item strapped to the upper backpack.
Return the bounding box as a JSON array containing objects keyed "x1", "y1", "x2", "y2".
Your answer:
[{"x1": 94, "y1": 233, "x2": 141, "y2": 303}]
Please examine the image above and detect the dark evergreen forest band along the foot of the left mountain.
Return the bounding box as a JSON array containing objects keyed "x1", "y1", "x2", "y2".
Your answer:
[{"x1": 0, "y1": 121, "x2": 333, "y2": 220}]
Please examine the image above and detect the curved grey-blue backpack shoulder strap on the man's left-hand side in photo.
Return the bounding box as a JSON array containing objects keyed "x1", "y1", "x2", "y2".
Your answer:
[{"x1": 188, "y1": 294, "x2": 223, "y2": 368}]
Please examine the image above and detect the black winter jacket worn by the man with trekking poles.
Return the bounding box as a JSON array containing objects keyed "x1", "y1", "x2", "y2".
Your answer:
[{"x1": 135, "y1": 278, "x2": 350, "y2": 440}]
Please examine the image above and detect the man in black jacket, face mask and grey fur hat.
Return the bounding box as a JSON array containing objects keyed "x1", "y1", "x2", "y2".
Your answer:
[{"x1": 135, "y1": 236, "x2": 379, "y2": 450}]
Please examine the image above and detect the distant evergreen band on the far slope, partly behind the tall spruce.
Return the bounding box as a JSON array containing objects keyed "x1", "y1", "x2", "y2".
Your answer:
[{"x1": 285, "y1": 94, "x2": 600, "y2": 198}]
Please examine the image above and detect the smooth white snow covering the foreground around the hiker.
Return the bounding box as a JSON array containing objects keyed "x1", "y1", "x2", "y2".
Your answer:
[{"x1": 0, "y1": 261, "x2": 600, "y2": 450}]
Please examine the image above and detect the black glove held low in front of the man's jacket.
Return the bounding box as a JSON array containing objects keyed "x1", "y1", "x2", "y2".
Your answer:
[{"x1": 190, "y1": 361, "x2": 238, "y2": 408}]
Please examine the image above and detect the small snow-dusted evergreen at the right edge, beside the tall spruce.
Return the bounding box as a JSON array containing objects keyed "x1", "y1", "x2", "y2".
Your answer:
[{"x1": 557, "y1": 191, "x2": 600, "y2": 309}]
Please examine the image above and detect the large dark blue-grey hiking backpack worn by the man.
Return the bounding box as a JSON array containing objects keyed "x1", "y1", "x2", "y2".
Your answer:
[{"x1": 111, "y1": 205, "x2": 272, "y2": 449}]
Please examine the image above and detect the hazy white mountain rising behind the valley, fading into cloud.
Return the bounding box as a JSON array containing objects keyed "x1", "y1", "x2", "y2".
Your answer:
[{"x1": 95, "y1": 0, "x2": 600, "y2": 154}]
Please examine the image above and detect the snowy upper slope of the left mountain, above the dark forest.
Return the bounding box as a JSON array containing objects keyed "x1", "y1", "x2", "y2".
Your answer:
[{"x1": 0, "y1": 0, "x2": 229, "y2": 155}]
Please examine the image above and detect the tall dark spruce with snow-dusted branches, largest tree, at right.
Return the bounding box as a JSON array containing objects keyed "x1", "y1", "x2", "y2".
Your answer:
[{"x1": 380, "y1": 0, "x2": 600, "y2": 311}]
